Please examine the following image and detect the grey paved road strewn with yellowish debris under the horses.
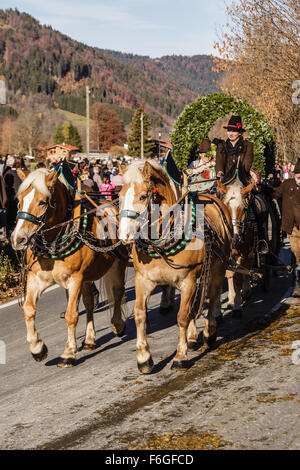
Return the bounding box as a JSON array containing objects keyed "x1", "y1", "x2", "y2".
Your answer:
[{"x1": 0, "y1": 244, "x2": 300, "y2": 450}]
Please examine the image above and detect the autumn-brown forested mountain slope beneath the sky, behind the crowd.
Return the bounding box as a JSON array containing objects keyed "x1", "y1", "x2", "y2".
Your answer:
[{"x1": 0, "y1": 9, "x2": 217, "y2": 127}]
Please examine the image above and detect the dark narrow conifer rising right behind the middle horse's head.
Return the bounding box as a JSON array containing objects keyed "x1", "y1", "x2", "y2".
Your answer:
[{"x1": 128, "y1": 107, "x2": 153, "y2": 158}]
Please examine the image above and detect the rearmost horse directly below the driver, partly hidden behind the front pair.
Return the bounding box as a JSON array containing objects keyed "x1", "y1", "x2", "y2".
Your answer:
[{"x1": 218, "y1": 180, "x2": 256, "y2": 316}]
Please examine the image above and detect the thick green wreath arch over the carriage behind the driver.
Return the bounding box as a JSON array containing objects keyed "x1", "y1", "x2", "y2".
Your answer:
[{"x1": 171, "y1": 93, "x2": 275, "y2": 177}]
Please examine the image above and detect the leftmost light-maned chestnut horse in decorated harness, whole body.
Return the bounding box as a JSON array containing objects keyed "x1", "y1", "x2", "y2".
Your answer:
[{"x1": 11, "y1": 168, "x2": 127, "y2": 367}]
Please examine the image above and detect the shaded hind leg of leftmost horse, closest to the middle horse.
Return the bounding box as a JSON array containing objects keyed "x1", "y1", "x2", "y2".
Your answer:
[{"x1": 110, "y1": 260, "x2": 127, "y2": 337}]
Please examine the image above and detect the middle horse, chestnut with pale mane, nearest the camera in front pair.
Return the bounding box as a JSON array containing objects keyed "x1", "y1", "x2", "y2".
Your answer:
[{"x1": 119, "y1": 160, "x2": 232, "y2": 374}]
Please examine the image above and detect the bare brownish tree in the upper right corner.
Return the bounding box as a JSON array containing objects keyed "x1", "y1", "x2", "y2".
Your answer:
[{"x1": 215, "y1": 0, "x2": 300, "y2": 160}]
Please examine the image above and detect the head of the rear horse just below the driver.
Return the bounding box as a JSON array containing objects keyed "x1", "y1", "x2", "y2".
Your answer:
[{"x1": 218, "y1": 181, "x2": 255, "y2": 244}]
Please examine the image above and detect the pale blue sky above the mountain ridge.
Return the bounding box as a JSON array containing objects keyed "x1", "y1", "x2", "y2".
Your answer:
[{"x1": 0, "y1": 0, "x2": 226, "y2": 57}]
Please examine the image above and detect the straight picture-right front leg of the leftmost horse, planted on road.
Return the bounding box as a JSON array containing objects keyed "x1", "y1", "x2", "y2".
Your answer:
[{"x1": 57, "y1": 276, "x2": 83, "y2": 367}]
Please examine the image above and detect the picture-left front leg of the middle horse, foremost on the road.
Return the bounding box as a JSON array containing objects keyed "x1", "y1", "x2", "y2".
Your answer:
[{"x1": 133, "y1": 273, "x2": 155, "y2": 374}]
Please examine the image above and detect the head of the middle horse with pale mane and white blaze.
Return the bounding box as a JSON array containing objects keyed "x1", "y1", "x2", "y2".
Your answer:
[{"x1": 119, "y1": 160, "x2": 174, "y2": 244}]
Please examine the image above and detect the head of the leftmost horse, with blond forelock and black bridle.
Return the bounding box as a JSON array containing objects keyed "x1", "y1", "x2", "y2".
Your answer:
[{"x1": 11, "y1": 168, "x2": 57, "y2": 250}]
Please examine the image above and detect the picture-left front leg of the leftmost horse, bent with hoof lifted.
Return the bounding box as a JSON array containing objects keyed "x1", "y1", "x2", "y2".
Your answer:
[{"x1": 23, "y1": 273, "x2": 54, "y2": 362}]
